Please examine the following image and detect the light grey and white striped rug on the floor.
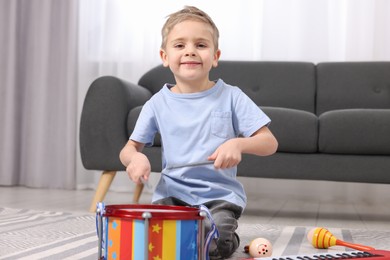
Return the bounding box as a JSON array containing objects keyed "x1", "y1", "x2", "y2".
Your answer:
[{"x1": 0, "y1": 208, "x2": 390, "y2": 260}]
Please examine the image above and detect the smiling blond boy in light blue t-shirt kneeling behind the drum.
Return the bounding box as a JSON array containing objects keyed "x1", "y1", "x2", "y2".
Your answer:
[{"x1": 120, "y1": 7, "x2": 278, "y2": 259}]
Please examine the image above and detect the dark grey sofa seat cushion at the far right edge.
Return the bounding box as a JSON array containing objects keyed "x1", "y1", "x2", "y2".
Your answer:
[{"x1": 319, "y1": 109, "x2": 390, "y2": 155}]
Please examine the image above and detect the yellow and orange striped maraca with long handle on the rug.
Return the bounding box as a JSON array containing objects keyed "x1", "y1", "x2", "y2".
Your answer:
[{"x1": 307, "y1": 227, "x2": 375, "y2": 251}]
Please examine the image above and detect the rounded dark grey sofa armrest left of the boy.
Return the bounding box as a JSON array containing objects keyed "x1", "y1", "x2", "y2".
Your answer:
[{"x1": 80, "y1": 76, "x2": 152, "y2": 171}]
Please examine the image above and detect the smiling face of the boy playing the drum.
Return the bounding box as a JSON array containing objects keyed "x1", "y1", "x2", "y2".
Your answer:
[{"x1": 160, "y1": 20, "x2": 220, "y2": 83}]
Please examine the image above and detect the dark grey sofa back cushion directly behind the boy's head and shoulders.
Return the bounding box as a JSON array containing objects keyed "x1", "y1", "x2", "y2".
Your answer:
[{"x1": 138, "y1": 61, "x2": 315, "y2": 113}]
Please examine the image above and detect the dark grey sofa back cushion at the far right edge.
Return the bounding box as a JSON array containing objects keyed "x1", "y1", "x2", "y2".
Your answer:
[{"x1": 316, "y1": 62, "x2": 390, "y2": 115}]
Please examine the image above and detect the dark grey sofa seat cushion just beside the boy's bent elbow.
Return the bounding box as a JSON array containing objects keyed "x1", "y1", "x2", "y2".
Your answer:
[{"x1": 261, "y1": 107, "x2": 318, "y2": 153}]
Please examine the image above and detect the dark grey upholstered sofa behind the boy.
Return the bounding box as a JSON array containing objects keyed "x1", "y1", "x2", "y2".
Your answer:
[{"x1": 80, "y1": 61, "x2": 390, "y2": 209}]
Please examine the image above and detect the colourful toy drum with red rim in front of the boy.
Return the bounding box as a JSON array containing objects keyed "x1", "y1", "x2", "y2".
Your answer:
[{"x1": 97, "y1": 204, "x2": 206, "y2": 260}]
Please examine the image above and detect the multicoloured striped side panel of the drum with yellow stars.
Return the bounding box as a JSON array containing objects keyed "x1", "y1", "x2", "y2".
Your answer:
[{"x1": 105, "y1": 218, "x2": 198, "y2": 260}]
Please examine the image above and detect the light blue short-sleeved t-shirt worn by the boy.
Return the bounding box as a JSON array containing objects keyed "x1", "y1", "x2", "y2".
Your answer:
[{"x1": 130, "y1": 79, "x2": 271, "y2": 209}]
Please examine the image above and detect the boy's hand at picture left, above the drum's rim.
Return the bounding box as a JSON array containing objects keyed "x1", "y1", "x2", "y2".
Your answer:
[{"x1": 126, "y1": 152, "x2": 151, "y2": 184}]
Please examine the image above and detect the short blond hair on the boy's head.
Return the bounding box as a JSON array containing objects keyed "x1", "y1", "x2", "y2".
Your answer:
[{"x1": 161, "y1": 6, "x2": 219, "y2": 50}]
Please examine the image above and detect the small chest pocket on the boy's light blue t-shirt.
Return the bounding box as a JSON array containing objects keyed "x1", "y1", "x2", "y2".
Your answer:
[{"x1": 211, "y1": 111, "x2": 235, "y2": 138}]
